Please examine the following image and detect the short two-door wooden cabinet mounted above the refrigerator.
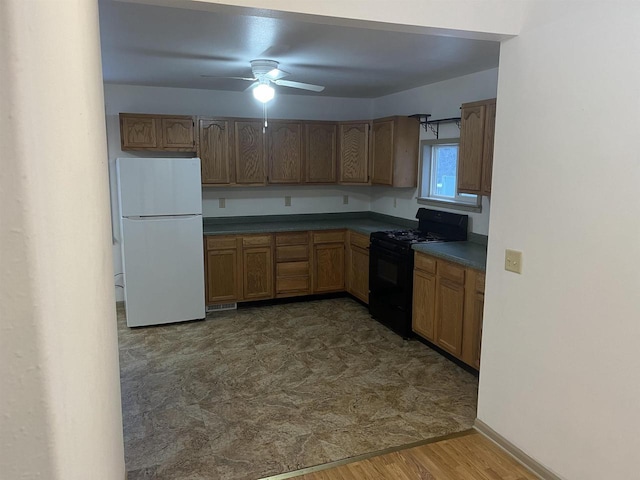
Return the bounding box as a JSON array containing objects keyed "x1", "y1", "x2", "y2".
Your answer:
[{"x1": 120, "y1": 113, "x2": 196, "y2": 152}]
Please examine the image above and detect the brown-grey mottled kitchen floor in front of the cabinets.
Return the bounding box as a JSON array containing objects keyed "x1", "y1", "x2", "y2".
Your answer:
[{"x1": 118, "y1": 298, "x2": 477, "y2": 480}]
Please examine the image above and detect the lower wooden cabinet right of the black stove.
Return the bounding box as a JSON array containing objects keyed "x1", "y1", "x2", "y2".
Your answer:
[{"x1": 413, "y1": 253, "x2": 484, "y2": 369}]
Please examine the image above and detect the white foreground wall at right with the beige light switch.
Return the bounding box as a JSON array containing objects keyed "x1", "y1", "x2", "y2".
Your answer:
[{"x1": 478, "y1": 1, "x2": 640, "y2": 480}]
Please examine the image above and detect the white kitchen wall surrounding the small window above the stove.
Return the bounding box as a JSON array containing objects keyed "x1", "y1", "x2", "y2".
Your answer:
[{"x1": 371, "y1": 68, "x2": 498, "y2": 235}]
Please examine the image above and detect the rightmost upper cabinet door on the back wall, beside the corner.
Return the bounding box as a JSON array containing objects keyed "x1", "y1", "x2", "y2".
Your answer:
[{"x1": 339, "y1": 122, "x2": 369, "y2": 183}]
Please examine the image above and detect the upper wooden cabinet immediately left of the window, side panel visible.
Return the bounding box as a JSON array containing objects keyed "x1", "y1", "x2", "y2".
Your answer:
[{"x1": 371, "y1": 117, "x2": 420, "y2": 187}]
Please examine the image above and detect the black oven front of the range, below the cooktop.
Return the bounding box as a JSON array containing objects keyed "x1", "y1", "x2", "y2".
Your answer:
[{"x1": 369, "y1": 244, "x2": 413, "y2": 337}]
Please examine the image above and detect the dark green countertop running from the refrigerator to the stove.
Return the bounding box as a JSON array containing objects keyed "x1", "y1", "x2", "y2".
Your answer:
[{"x1": 203, "y1": 212, "x2": 417, "y2": 235}]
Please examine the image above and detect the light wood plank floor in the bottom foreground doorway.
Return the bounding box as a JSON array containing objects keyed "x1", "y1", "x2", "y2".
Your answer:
[{"x1": 282, "y1": 431, "x2": 538, "y2": 480}]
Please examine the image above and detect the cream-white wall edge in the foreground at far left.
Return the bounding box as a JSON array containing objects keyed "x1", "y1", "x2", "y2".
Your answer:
[{"x1": 0, "y1": 0, "x2": 125, "y2": 480}]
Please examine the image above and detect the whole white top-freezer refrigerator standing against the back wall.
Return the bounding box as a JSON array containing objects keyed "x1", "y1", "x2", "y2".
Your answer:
[{"x1": 116, "y1": 158, "x2": 205, "y2": 327}]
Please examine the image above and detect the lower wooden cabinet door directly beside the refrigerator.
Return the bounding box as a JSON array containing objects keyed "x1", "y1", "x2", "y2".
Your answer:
[{"x1": 207, "y1": 249, "x2": 240, "y2": 304}]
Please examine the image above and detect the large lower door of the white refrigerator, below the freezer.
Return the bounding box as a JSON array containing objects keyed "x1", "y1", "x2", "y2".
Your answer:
[{"x1": 122, "y1": 215, "x2": 205, "y2": 327}]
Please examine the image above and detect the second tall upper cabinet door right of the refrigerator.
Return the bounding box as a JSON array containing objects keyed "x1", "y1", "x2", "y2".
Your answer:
[{"x1": 234, "y1": 121, "x2": 266, "y2": 184}]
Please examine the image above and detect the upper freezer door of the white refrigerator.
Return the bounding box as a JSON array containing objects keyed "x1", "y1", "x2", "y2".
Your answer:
[{"x1": 116, "y1": 158, "x2": 202, "y2": 217}]
